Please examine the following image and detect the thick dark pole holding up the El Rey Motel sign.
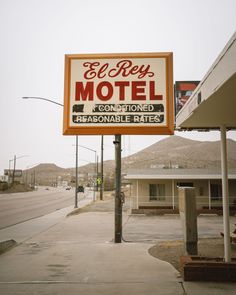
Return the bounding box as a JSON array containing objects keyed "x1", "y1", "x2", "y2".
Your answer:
[{"x1": 114, "y1": 135, "x2": 122, "y2": 243}]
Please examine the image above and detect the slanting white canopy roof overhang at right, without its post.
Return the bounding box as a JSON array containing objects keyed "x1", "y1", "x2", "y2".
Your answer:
[{"x1": 176, "y1": 32, "x2": 236, "y2": 130}]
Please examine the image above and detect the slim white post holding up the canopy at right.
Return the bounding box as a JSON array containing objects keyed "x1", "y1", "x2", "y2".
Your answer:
[{"x1": 220, "y1": 125, "x2": 231, "y2": 262}]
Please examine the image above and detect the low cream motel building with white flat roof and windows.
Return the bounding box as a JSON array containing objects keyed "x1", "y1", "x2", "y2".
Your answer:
[{"x1": 125, "y1": 168, "x2": 236, "y2": 214}]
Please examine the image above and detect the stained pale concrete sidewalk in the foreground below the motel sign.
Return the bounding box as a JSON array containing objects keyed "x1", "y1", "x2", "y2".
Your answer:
[{"x1": 0, "y1": 212, "x2": 183, "y2": 295}]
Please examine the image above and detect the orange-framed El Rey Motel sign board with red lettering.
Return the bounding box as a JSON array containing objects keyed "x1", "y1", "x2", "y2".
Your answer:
[{"x1": 64, "y1": 53, "x2": 174, "y2": 135}]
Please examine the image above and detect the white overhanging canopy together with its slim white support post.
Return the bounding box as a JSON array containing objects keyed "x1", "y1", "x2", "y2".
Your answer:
[{"x1": 176, "y1": 33, "x2": 236, "y2": 262}]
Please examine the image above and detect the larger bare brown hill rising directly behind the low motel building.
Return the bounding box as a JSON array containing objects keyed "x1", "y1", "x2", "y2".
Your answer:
[{"x1": 123, "y1": 135, "x2": 236, "y2": 168}]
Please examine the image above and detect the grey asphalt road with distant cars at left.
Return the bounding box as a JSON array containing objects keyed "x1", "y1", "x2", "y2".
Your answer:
[{"x1": 0, "y1": 187, "x2": 74, "y2": 229}]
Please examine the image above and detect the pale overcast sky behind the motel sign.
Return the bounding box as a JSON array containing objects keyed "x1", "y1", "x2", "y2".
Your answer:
[{"x1": 0, "y1": 0, "x2": 236, "y2": 175}]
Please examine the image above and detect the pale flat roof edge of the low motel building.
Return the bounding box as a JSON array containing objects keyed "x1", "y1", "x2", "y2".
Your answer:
[{"x1": 125, "y1": 168, "x2": 236, "y2": 180}]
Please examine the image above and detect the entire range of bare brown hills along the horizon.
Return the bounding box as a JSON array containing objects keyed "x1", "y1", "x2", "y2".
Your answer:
[{"x1": 24, "y1": 135, "x2": 236, "y2": 185}]
